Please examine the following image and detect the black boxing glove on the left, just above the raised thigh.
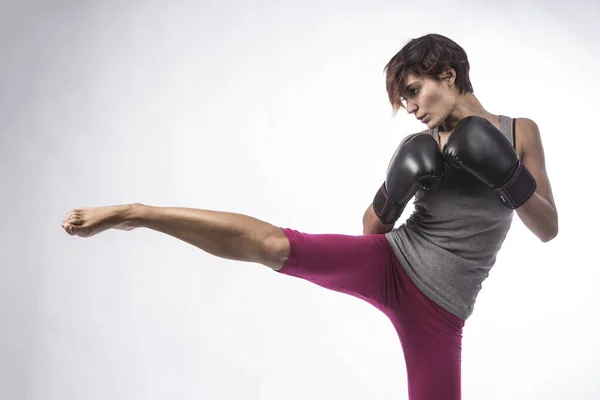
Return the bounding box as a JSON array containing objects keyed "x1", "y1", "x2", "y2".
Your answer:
[{"x1": 373, "y1": 133, "x2": 445, "y2": 224}]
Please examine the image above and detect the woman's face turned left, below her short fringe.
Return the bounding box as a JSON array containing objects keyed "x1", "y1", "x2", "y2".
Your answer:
[{"x1": 402, "y1": 74, "x2": 456, "y2": 129}]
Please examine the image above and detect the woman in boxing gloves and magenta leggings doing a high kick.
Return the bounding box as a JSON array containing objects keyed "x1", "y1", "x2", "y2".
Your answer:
[{"x1": 62, "y1": 34, "x2": 558, "y2": 400}]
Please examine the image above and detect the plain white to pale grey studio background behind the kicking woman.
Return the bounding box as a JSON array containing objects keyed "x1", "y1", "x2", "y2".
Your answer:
[{"x1": 0, "y1": 0, "x2": 600, "y2": 400}]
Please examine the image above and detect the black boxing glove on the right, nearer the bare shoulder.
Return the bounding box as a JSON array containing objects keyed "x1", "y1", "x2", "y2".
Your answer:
[{"x1": 443, "y1": 116, "x2": 537, "y2": 210}]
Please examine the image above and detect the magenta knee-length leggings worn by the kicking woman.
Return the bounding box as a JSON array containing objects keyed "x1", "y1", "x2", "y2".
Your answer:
[{"x1": 279, "y1": 229, "x2": 465, "y2": 400}]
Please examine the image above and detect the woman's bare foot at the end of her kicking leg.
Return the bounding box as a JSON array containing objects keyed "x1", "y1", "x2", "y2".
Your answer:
[{"x1": 61, "y1": 205, "x2": 136, "y2": 237}]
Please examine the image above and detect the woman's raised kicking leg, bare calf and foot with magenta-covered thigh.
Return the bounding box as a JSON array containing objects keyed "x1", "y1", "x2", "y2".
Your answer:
[{"x1": 62, "y1": 204, "x2": 397, "y2": 309}]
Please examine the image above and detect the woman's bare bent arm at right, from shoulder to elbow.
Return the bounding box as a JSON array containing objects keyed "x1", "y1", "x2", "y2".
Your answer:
[{"x1": 516, "y1": 118, "x2": 558, "y2": 243}]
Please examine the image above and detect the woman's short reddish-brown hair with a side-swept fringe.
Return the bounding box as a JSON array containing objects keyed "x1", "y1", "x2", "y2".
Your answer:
[{"x1": 384, "y1": 33, "x2": 473, "y2": 114}]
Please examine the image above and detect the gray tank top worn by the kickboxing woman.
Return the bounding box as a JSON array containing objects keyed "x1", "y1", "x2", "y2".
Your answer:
[{"x1": 386, "y1": 116, "x2": 515, "y2": 320}]
